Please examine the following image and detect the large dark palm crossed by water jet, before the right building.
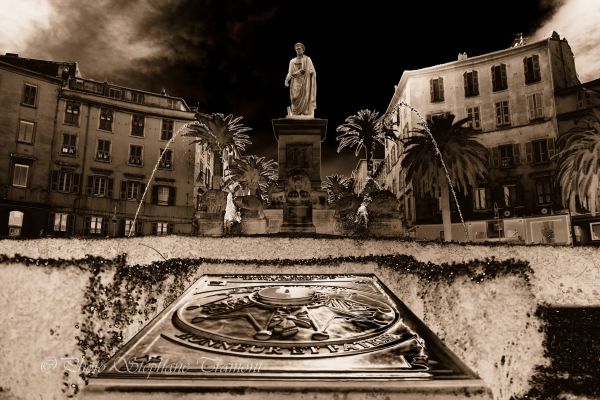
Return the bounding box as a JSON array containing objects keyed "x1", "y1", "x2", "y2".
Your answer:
[{"x1": 401, "y1": 113, "x2": 488, "y2": 241}]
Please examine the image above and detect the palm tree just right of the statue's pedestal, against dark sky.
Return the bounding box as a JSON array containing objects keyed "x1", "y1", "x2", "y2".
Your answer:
[{"x1": 336, "y1": 110, "x2": 396, "y2": 180}]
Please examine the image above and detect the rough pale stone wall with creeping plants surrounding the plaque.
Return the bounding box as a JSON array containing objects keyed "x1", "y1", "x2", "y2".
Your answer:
[{"x1": 0, "y1": 236, "x2": 600, "y2": 399}]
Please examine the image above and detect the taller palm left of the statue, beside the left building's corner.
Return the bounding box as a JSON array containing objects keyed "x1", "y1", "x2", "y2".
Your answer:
[{"x1": 183, "y1": 113, "x2": 252, "y2": 188}]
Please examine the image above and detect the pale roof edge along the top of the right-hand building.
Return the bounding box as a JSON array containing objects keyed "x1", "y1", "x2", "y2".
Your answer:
[{"x1": 385, "y1": 37, "x2": 568, "y2": 114}]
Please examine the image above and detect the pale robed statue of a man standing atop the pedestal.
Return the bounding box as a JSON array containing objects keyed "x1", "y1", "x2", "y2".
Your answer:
[{"x1": 285, "y1": 43, "x2": 317, "y2": 118}]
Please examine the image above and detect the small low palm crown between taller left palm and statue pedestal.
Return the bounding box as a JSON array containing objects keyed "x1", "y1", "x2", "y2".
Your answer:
[{"x1": 226, "y1": 155, "x2": 278, "y2": 198}]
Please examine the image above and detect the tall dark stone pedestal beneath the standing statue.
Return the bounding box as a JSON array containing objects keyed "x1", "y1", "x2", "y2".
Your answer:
[{"x1": 272, "y1": 118, "x2": 327, "y2": 233}]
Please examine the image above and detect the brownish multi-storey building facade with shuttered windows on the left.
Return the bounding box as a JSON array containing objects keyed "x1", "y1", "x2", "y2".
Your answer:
[{"x1": 0, "y1": 55, "x2": 212, "y2": 236}]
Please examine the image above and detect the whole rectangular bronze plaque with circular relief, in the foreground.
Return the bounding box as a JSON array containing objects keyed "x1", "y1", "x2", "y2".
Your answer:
[{"x1": 94, "y1": 275, "x2": 474, "y2": 387}]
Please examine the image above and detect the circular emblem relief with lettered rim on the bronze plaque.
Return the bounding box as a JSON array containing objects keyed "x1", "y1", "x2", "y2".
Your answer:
[{"x1": 172, "y1": 285, "x2": 406, "y2": 358}]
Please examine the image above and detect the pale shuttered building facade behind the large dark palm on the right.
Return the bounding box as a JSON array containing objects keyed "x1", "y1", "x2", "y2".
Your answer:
[{"x1": 385, "y1": 34, "x2": 579, "y2": 244}]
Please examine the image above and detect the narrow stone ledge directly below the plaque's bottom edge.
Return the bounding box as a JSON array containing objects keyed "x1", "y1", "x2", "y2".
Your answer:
[{"x1": 83, "y1": 379, "x2": 492, "y2": 400}]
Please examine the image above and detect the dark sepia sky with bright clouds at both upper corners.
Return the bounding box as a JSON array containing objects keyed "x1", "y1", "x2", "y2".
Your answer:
[{"x1": 0, "y1": 0, "x2": 600, "y2": 175}]
